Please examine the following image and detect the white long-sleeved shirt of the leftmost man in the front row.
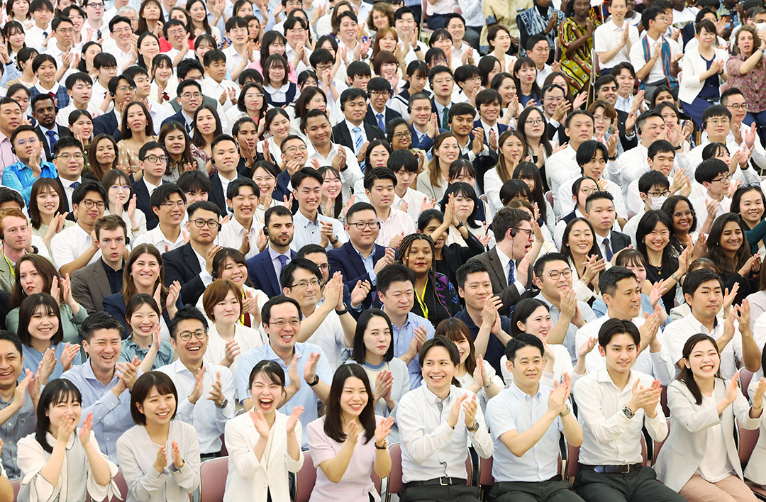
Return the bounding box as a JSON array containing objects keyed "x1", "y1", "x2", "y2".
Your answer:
[{"x1": 396, "y1": 385, "x2": 493, "y2": 483}]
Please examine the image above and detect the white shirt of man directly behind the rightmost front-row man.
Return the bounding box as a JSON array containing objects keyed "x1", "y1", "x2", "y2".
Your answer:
[{"x1": 575, "y1": 313, "x2": 680, "y2": 385}]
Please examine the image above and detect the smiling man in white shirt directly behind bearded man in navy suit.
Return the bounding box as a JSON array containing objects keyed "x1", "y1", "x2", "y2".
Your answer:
[{"x1": 290, "y1": 167, "x2": 348, "y2": 253}]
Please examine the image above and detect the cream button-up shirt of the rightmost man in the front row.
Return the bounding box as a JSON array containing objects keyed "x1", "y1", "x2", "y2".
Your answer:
[{"x1": 573, "y1": 367, "x2": 668, "y2": 465}]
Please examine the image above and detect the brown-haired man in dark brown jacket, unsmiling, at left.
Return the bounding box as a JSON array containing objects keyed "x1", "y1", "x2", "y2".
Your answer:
[{"x1": 72, "y1": 214, "x2": 128, "y2": 314}]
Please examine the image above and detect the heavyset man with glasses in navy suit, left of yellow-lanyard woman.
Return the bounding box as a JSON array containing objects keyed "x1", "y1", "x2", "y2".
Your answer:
[{"x1": 327, "y1": 202, "x2": 396, "y2": 308}]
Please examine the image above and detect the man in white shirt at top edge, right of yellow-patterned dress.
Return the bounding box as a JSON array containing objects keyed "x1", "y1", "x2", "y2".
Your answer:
[{"x1": 593, "y1": 0, "x2": 638, "y2": 72}]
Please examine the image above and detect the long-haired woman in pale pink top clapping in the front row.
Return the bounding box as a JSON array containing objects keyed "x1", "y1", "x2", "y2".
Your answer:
[{"x1": 307, "y1": 364, "x2": 394, "y2": 502}]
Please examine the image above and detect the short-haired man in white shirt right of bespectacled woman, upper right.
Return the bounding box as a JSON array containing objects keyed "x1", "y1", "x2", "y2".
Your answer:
[{"x1": 546, "y1": 110, "x2": 594, "y2": 216}]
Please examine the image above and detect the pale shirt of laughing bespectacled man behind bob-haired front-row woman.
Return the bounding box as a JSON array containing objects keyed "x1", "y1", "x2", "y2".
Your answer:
[{"x1": 157, "y1": 359, "x2": 235, "y2": 454}]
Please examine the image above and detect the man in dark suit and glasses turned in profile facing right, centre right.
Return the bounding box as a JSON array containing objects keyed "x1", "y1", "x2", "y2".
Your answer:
[{"x1": 464, "y1": 207, "x2": 534, "y2": 316}]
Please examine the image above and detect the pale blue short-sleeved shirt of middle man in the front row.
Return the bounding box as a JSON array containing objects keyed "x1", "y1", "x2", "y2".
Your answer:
[{"x1": 486, "y1": 383, "x2": 563, "y2": 483}]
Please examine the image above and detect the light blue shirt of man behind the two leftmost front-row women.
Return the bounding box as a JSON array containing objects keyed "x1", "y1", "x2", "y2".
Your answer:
[{"x1": 61, "y1": 358, "x2": 138, "y2": 464}]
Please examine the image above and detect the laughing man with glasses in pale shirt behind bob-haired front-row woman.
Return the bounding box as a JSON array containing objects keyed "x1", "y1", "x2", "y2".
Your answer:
[{"x1": 157, "y1": 305, "x2": 235, "y2": 459}]
